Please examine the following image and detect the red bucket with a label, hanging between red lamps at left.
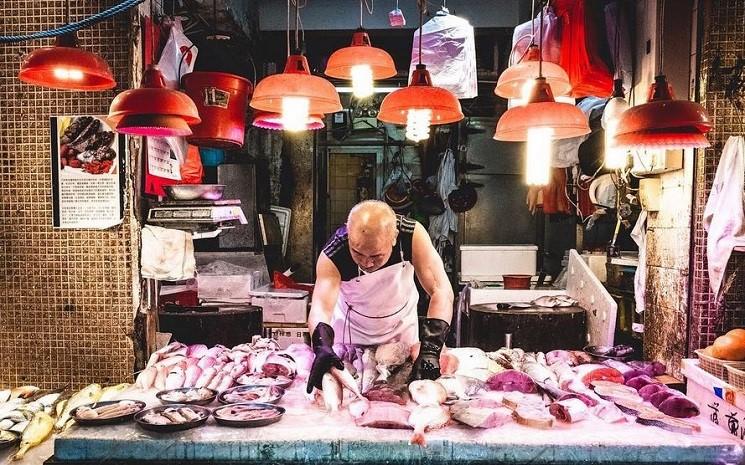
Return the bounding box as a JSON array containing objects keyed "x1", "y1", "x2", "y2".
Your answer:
[{"x1": 181, "y1": 71, "x2": 253, "y2": 150}]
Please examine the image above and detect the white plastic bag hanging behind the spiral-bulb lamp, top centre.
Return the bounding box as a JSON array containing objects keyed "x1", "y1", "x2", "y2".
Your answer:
[{"x1": 409, "y1": 11, "x2": 478, "y2": 99}]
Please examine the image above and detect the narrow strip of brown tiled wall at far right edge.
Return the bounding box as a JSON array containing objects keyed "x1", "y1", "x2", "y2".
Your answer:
[{"x1": 688, "y1": 0, "x2": 745, "y2": 351}]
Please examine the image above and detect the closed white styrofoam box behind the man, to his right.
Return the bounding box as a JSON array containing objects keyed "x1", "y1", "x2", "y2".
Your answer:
[{"x1": 460, "y1": 245, "x2": 538, "y2": 281}]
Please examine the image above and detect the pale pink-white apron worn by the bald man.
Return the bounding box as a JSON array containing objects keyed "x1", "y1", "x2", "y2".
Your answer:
[{"x1": 331, "y1": 245, "x2": 419, "y2": 346}]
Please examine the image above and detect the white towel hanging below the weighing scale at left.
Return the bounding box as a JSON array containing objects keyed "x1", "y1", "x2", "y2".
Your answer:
[{"x1": 140, "y1": 225, "x2": 196, "y2": 281}]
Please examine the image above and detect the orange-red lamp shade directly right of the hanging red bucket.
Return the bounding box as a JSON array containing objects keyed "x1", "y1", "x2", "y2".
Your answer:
[{"x1": 250, "y1": 55, "x2": 342, "y2": 115}]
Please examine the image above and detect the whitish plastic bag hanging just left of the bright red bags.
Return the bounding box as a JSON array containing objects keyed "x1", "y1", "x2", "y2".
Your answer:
[{"x1": 509, "y1": 6, "x2": 561, "y2": 66}]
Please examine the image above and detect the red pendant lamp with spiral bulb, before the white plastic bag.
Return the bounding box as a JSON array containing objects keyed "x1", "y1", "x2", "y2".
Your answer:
[{"x1": 378, "y1": 6, "x2": 464, "y2": 142}]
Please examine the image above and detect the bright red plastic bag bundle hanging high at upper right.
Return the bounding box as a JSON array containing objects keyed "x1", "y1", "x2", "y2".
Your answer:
[{"x1": 553, "y1": 0, "x2": 613, "y2": 98}]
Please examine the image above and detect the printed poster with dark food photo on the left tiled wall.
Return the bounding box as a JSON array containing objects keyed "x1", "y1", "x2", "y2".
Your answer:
[{"x1": 50, "y1": 116, "x2": 126, "y2": 229}]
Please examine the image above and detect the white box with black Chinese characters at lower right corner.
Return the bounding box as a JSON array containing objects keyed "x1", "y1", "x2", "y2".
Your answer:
[{"x1": 683, "y1": 359, "x2": 745, "y2": 442}]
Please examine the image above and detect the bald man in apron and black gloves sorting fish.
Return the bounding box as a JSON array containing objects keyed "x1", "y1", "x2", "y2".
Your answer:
[{"x1": 307, "y1": 200, "x2": 453, "y2": 393}]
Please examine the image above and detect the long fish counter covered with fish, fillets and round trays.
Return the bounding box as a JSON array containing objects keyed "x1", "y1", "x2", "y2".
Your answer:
[{"x1": 2, "y1": 338, "x2": 745, "y2": 465}]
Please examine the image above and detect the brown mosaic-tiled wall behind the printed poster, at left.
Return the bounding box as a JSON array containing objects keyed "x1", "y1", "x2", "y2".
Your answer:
[{"x1": 0, "y1": 0, "x2": 136, "y2": 388}]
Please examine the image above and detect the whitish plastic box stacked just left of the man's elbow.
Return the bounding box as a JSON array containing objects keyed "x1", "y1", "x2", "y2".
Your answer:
[{"x1": 251, "y1": 286, "x2": 308, "y2": 326}]
